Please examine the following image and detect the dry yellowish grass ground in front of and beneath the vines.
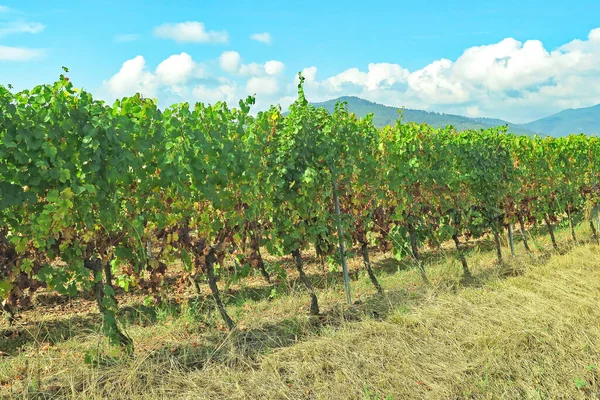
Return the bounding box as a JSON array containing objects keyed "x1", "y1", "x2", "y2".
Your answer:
[{"x1": 0, "y1": 223, "x2": 600, "y2": 399}]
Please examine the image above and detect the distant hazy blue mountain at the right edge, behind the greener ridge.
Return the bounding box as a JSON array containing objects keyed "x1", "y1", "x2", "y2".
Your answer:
[{"x1": 521, "y1": 104, "x2": 600, "y2": 137}]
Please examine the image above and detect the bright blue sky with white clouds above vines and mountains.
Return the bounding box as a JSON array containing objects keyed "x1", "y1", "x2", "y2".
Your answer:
[{"x1": 0, "y1": 0, "x2": 600, "y2": 123}]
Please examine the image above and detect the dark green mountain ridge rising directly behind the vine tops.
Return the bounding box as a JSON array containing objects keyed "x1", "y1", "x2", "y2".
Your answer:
[{"x1": 313, "y1": 96, "x2": 533, "y2": 135}]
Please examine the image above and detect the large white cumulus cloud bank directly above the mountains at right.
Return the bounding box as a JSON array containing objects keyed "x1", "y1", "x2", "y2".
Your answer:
[{"x1": 295, "y1": 28, "x2": 600, "y2": 122}]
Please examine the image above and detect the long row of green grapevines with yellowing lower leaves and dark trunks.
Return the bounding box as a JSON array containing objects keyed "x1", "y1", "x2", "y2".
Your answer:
[{"x1": 0, "y1": 69, "x2": 600, "y2": 396}]
